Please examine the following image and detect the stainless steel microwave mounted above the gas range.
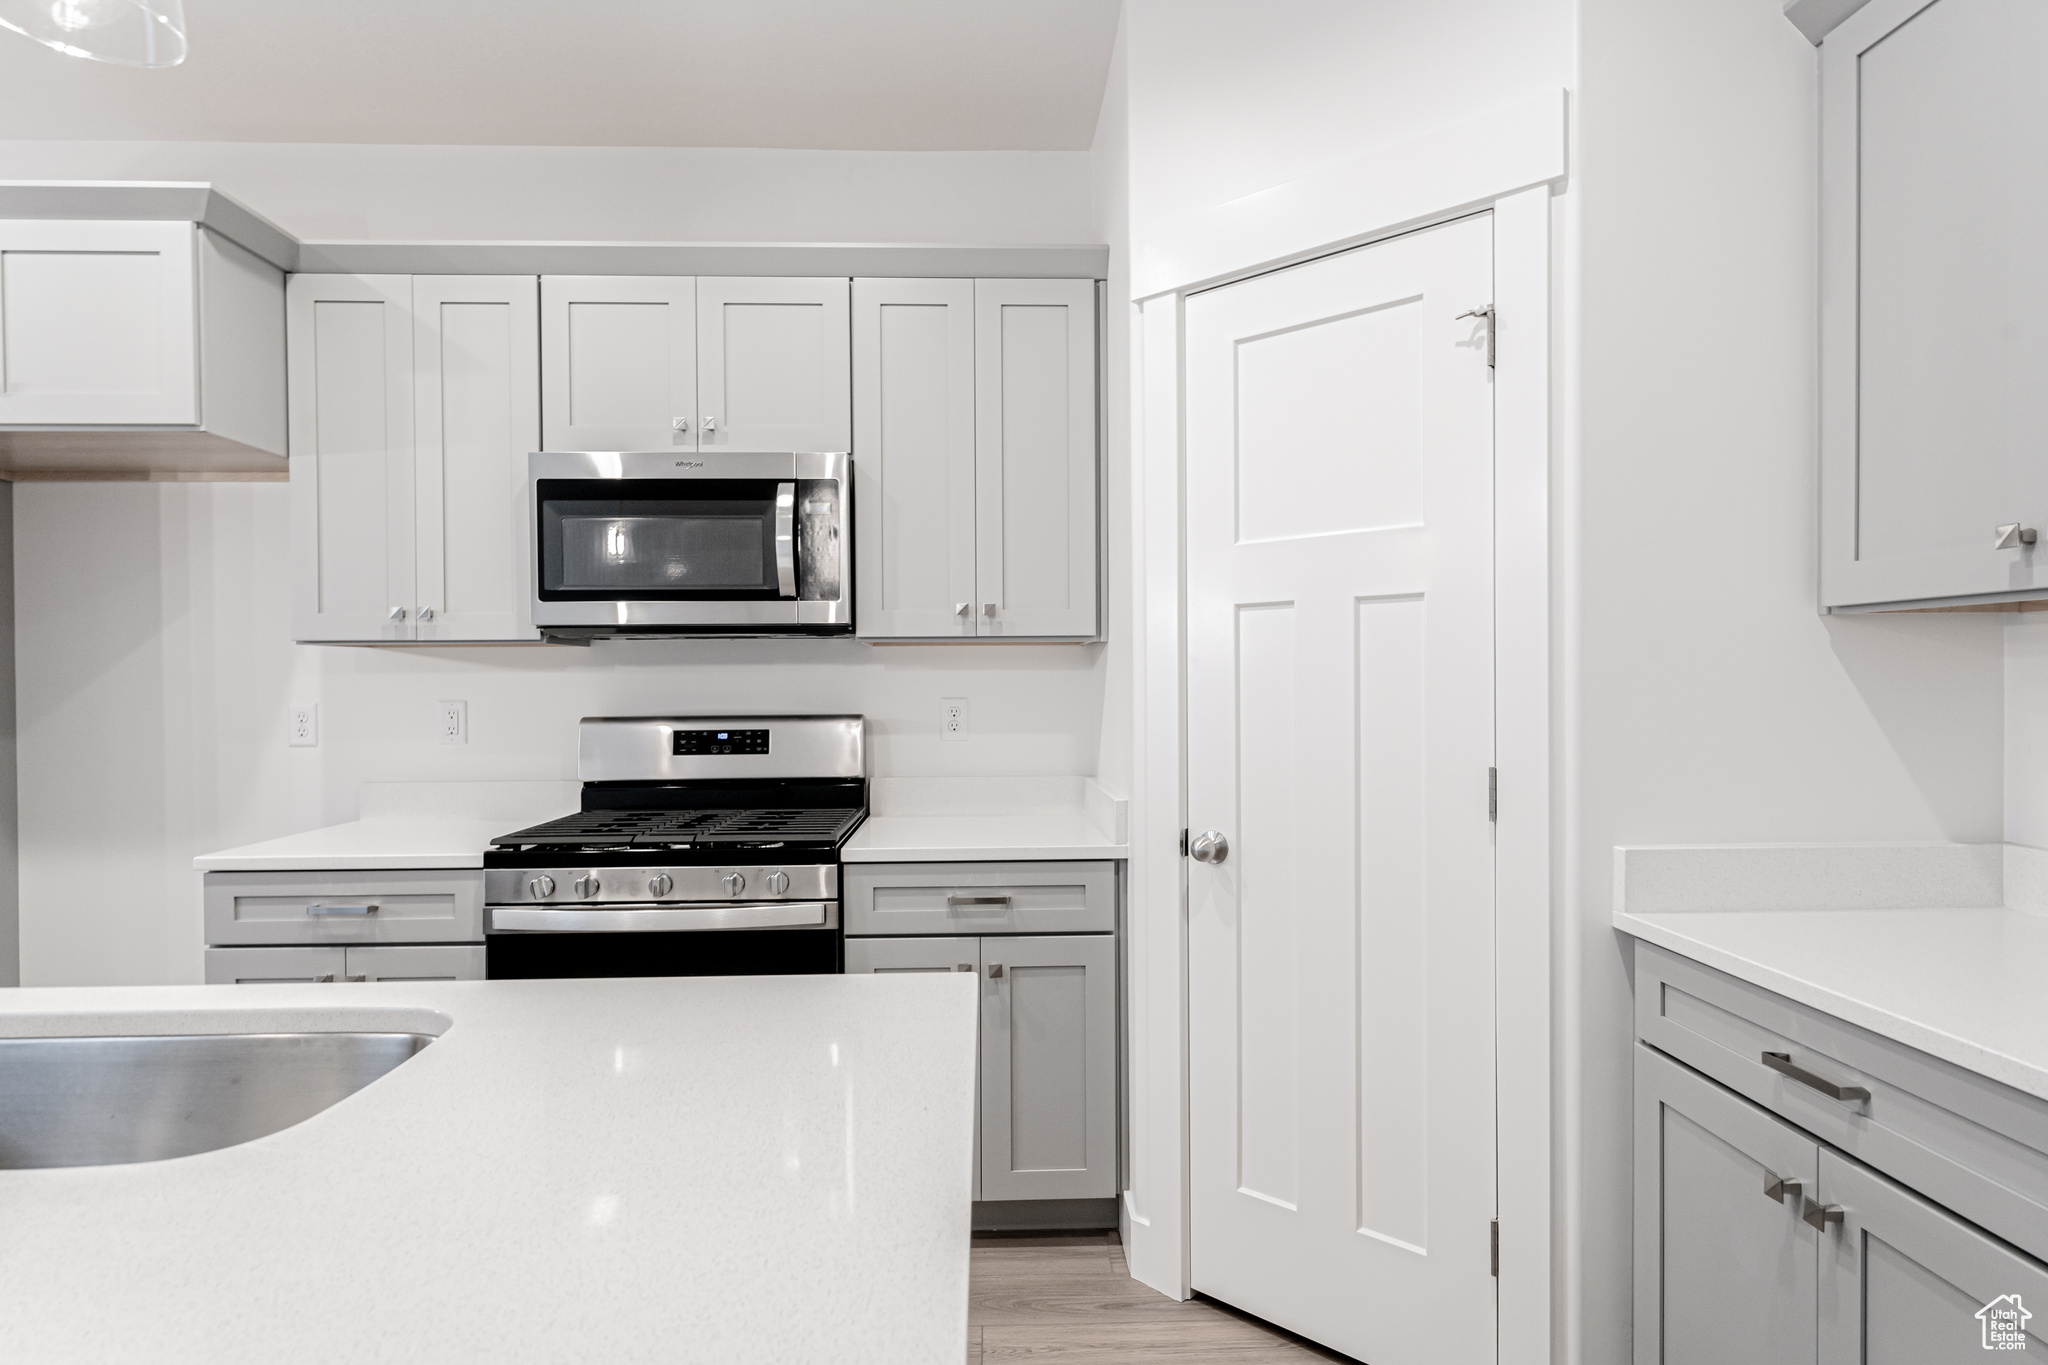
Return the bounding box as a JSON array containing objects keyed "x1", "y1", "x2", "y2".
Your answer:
[{"x1": 526, "y1": 450, "x2": 854, "y2": 641}]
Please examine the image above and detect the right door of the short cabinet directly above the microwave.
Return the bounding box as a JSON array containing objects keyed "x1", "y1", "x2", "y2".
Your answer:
[{"x1": 696, "y1": 274, "x2": 854, "y2": 450}]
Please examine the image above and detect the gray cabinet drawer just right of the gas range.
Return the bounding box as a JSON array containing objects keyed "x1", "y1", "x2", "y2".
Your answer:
[{"x1": 842, "y1": 862, "x2": 1116, "y2": 935}]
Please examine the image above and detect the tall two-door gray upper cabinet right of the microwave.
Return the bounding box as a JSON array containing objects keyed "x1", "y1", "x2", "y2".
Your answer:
[{"x1": 854, "y1": 280, "x2": 1100, "y2": 639}]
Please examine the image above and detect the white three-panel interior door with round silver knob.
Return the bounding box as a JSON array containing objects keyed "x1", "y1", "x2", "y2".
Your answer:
[{"x1": 1184, "y1": 215, "x2": 1495, "y2": 1365}]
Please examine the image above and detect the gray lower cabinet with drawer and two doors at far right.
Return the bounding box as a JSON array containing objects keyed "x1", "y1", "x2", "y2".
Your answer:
[{"x1": 1634, "y1": 943, "x2": 2048, "y2": 1365}]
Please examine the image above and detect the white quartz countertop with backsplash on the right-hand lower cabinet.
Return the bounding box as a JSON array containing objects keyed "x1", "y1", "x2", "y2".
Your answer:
[{"x1": 1614, "y1": 845, "x2": 2048, "y2": 1099}]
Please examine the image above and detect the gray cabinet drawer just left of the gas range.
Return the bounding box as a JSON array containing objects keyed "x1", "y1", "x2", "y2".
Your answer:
[{"x1": 205, "y1": 868, "x2": 483, "y2": 948}]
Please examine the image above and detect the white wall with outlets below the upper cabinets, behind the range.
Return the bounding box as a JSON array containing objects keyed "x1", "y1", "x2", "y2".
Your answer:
[{"x1": 14, "y1": 483, "x2": 1102, "y2": 986}]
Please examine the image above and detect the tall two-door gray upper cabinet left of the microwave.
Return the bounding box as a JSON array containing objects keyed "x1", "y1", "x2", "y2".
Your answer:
[{"x1": 287, "y1": 274, "x2": 541, "y2": 643}]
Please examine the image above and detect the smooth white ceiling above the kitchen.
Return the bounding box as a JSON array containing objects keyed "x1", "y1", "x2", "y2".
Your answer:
[{"x1": 0, "y1": 0, "x2": 1118, "y2": 151}]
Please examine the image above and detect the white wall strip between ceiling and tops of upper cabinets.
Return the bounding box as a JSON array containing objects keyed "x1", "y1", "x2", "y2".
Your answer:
[{"x1": 0, "y1": 141, "x2": 1102, "y2": 246}]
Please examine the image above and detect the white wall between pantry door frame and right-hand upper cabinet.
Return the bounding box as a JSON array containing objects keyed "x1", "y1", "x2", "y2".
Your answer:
[{"x1": 1559, "y1": 0, "x2": 2001, "y2": 1365}]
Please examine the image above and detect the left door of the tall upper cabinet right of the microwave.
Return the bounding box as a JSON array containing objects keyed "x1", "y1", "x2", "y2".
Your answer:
[{"x1": 854, "y1": 280, "x2": 977, "y2": 639}]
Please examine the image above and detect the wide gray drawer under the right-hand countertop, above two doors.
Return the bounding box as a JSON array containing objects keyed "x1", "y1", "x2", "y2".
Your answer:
[{"x1": 1636, "y1": 941, "x2": 2048, "y2": 1257}]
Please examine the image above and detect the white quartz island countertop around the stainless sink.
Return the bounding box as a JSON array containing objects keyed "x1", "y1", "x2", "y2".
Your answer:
[{"x1": 0, "y1": 974, "x2": 977, "y2": 1365}]
